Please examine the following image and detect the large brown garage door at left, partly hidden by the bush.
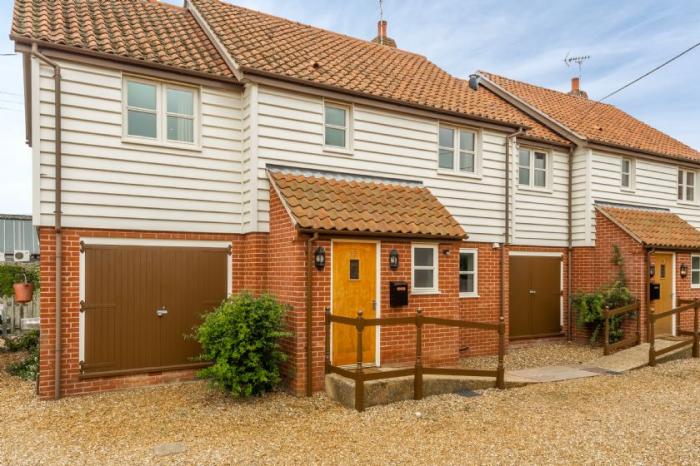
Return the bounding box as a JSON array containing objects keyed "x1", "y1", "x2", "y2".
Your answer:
[{"x1": 81, "y1": 245, "x2": 228, "y2": 376}]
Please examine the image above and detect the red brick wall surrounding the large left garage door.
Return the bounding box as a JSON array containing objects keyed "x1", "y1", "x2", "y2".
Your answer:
[{"x1": 39, "y1": 228, "x2": 266, "y2": 398}]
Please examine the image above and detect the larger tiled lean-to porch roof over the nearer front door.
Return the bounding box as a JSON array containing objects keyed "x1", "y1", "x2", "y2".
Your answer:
[{"x1": 270, "y1": 172, "x2": 466, "y2": 239}]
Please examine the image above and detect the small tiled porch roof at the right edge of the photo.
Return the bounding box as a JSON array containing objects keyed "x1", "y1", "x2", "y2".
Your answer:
[{"x1": 598, "y1": 206, "x2": 700, "y2": 249}]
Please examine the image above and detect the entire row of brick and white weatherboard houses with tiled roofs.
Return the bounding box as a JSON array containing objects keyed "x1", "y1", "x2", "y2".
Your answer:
[{"x1": 11, "y1": 0, "x2": 700, "y2": 398}]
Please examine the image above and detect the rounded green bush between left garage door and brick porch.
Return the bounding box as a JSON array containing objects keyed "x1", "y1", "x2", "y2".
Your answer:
[{"x1": 194, "y1": 293, "x2": 290, "y2": 397}]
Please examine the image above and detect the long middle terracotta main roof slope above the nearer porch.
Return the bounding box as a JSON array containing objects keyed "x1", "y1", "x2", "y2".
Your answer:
[{"x1": 191, "y1": 0, "x2": 567, "y2": 144}]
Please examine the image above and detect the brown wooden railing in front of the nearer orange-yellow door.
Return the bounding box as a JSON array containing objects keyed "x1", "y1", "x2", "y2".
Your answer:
[{"x1": 325, "y1": 308, "x2": 506, "y2": 411}]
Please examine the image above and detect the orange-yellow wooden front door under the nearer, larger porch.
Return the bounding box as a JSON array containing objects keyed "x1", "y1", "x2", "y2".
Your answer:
[{"x1": 331, "y1": 241, "x2": 377, "y2": 366}]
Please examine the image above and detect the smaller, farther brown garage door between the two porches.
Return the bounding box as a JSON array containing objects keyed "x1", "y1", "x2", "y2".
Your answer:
[{"x1": 509, "y1": 256, "x2": 562, "y2": 338}]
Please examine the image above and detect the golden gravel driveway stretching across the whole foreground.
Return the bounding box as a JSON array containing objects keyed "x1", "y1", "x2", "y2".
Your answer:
[{"x1": 0, "y1": 354, "x2": 700, "y2": 465}]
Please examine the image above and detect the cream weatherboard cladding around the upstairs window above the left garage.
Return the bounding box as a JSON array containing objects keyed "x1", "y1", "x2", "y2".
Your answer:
[{"x1": 32, "y1": 60, "x2": 242, "y2": 233}]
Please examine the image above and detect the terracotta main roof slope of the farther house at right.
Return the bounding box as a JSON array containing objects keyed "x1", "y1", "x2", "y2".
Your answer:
[{"x1": 480, "y1": 72, "x2": 700, "y2": 161}]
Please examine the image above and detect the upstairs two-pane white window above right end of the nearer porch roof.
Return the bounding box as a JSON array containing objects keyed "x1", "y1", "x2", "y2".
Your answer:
[{"x1": 438, "y1": 126, "x2": 477, "y2": 173}]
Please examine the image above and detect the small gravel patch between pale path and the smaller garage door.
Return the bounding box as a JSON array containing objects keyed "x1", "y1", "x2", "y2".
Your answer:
[{"x1": 461, "y1": 343, "x2": 603, "y2": 371}]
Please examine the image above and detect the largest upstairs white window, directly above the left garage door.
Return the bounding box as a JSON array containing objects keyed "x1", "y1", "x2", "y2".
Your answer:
[{"x1": 124, "y1": 78, "x2": 198, "y2": 145}]
